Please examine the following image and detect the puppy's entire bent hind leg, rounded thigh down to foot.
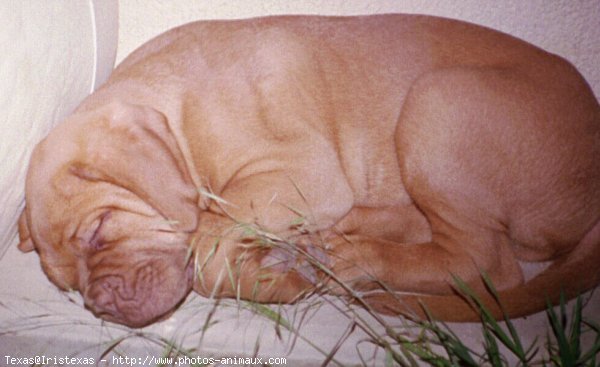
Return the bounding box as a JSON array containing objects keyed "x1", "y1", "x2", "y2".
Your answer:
[{"x1": 333, "y1": 64, "x2": 600, "y2": 316}]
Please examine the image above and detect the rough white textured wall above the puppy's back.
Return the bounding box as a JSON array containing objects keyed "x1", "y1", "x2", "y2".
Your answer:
[{"x1": 117, "y1": 0, "x2": 600, "y2": 97}]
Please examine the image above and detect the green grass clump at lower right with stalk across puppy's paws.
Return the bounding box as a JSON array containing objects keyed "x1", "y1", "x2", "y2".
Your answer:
[{"x1": 226, "y1": 217, "x2": 600, "y2": 367}]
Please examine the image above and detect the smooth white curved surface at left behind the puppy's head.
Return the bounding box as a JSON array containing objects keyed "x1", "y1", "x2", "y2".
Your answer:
[{"x1": 0, "y1": 0, "x2": 118, "y2": 257}]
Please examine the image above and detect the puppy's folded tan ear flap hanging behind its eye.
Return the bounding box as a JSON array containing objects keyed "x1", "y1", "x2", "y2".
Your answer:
[{"x1": 75, "y1": 103, "x2": 199, "y2": 232}]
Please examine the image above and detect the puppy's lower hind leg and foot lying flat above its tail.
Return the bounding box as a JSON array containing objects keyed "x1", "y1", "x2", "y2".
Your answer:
[{"x1": 328, "y1": 230, "x2": 523, "y2": 295}]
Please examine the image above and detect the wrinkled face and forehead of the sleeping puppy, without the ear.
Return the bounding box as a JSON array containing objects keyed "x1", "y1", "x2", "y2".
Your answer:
[{"x1": 20, "y1": 103, "x2": 199, "y2": 327}]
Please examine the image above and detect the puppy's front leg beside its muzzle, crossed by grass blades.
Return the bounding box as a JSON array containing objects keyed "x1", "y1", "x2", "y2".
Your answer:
[{"x1": 190, "y1": 213, "x2": 320, "y2": 303}]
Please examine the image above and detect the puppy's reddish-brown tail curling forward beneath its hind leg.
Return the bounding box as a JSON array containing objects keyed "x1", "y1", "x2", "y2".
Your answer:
[{"x1": 367, "y1": 221, "x2": 600, "y2": 322}]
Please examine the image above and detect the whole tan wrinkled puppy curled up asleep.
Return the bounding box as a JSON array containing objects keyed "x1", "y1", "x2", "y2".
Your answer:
[{"x1": 20, "y1": 15, "x2": 600, "y2": 326}]
